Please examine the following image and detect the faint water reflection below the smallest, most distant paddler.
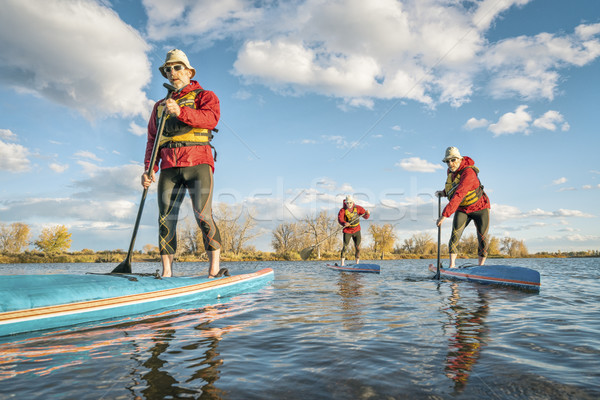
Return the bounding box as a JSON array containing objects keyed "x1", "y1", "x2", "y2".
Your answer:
[{"x1": 337, "y1": 272, "x2": 364, "y2": 331}]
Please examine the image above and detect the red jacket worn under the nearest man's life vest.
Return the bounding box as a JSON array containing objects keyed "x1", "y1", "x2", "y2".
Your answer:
[{"x1": 144, "y1": 81, "x2": 221, "y2": 172}]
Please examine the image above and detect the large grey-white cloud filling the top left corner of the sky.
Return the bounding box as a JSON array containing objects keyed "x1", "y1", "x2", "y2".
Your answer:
[{"x1": 0, "y1": 0, "x2": 151, "y2": 119}]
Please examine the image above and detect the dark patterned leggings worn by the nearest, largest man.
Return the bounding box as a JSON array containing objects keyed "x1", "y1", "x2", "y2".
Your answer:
[{"x1": 158, "y1": 164, "x2": 221, "y2": 255}]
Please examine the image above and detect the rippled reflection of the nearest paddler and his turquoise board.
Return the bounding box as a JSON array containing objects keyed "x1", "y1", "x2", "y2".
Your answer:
[{"x1": 0, "y1": 304, "x2": 246, "y2": 399}]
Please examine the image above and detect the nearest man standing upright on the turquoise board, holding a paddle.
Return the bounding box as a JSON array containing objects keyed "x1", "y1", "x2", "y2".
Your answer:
[{"x1": 142, "y1": 49, "x2": 225, "y2": 278}]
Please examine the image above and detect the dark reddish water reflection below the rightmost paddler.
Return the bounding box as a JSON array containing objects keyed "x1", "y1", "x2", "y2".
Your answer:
[{"x1": 444, "y1": 283, "x2": 489, "y2": 392}]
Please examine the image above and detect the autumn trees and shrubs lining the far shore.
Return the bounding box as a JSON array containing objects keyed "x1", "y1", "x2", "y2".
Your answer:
[{"x1": 0, "y1": 209, "x2": 599, "y2": 262}]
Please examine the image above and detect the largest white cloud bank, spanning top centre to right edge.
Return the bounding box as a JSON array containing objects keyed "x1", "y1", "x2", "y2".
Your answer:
[{"x1": 144, "y1": 0, "x2": 600, "y2": 107}]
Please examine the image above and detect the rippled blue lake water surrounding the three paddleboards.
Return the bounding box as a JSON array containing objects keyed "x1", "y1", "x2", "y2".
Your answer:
[{"x1": 0, "y1": 259, "x2": 600, "y2": 400}]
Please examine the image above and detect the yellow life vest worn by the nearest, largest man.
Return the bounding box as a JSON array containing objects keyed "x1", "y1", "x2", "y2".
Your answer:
[{"x1": 156, "y1": 89, "x2": 217, "y2": 147}]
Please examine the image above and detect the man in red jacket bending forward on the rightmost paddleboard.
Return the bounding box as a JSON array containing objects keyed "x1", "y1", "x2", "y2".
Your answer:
[{"x1": 435, "y1": 147, "x2": 490, "y2": 268}]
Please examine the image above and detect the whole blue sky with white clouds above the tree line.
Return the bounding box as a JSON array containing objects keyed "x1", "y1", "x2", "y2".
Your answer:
[{"x1": 0, "y1": 0, "x2": 600, "y2": 252}]
